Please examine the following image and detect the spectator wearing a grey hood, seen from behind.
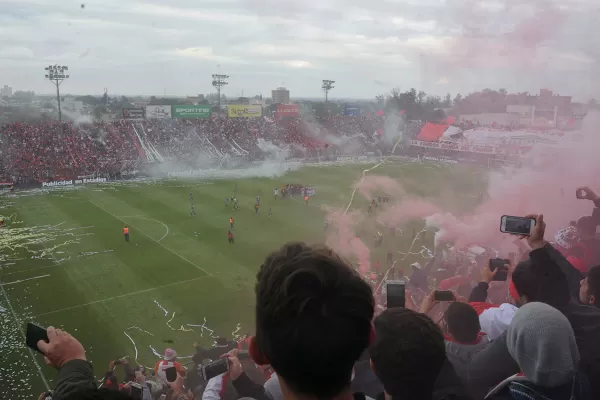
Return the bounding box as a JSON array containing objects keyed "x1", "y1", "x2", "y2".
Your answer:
[{"x1": 486, "y1": 303, "x2": 591, "y2": 400}]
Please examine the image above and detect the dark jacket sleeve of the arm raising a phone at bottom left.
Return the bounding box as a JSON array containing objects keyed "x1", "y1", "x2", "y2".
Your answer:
[{"x1": 52, "y1": 360, "x2": 96, "y2": 400}]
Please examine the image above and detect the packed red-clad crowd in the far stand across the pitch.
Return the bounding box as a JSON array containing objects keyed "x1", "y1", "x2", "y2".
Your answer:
[{"x1": 0, "y1": 117, "x2": 380, "y2": 183}]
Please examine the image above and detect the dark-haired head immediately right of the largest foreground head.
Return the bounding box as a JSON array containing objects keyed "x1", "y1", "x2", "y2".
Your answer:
[{"x1": 369, "y1": 308, "x2": 446, "y2": 399}]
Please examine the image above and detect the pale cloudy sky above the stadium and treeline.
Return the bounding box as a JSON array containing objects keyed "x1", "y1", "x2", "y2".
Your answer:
[{"x1": 0, "y1": 0, "x2": 600, "y2": 101}]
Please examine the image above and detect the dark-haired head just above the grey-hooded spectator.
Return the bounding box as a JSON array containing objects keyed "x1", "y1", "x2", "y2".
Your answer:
[{"x1": 512, "y1": 260, "x2": 571, "y2": 307}]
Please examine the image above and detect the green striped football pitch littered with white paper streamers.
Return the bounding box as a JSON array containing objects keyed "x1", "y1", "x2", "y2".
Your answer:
[{"x1": 0, "y1": 164, "x2": 485, "y2": 399}]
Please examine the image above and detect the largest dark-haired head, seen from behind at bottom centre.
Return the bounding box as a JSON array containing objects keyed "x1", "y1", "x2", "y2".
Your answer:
[{"x1": 251, "y1": 243, "x2": 374, "y2": 397}]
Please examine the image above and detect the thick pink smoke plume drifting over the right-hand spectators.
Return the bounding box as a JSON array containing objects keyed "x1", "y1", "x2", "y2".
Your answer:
[{"x1": 328, "y1": 113, "x2": 600, "y2": 258}]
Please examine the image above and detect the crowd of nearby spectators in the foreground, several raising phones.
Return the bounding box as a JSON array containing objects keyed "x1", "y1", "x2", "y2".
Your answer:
[{"x1": 38, "y1": 188, "x2": 600, "y2": 400}]
